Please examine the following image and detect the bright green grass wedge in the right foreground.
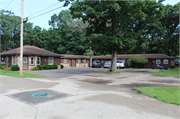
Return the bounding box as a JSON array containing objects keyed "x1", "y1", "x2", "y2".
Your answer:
[{"x1": 134, "y1": 87, "x2": 180, "y2": 105}]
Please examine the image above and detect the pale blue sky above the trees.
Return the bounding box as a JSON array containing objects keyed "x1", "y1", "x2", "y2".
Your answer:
[{"x1": 0, "y1": 0, "x2": 180, "y2": 30}]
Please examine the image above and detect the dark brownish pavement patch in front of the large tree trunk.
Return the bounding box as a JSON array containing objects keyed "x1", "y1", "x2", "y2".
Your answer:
[{"x1": 80, "y1": 78, "x2": 112, "y2": 85}]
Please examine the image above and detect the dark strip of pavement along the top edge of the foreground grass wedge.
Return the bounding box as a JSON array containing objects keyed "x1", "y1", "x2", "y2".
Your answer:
[{"x1": 116, "y1": 83, "x2": 178, "y2": 88}]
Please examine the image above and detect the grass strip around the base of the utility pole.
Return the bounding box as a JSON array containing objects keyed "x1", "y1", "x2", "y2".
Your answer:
[{"x1": 0, "y1": 70, "x2": 45, "y2": 78}]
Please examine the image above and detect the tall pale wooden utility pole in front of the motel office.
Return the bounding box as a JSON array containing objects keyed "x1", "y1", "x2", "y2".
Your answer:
[{"x1": 20, "y1": 0, "x2": 24, "y2": 75}]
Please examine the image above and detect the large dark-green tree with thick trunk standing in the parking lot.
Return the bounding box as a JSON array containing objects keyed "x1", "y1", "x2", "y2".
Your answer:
[{"x1": 70, "y1": 1, "x2": 160, "y2": 72}]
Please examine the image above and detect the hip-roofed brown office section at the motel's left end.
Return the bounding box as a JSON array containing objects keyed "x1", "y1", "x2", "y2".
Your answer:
[{"x1": 0, "y1": 45, "x2": 62, "y2": 70}]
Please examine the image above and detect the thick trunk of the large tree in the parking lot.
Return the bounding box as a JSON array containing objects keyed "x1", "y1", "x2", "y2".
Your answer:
[{"x1": 111, "y1": 48, "x2": 117, "y2": 72}]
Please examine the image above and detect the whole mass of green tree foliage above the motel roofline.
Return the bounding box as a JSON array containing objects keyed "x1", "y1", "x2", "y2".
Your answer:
[{"x1": 0, "y1": 0, "x2": 180, "y2": 71}]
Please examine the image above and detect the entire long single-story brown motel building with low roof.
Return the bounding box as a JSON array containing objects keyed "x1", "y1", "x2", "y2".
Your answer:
[{"x1": 0, "y1": 45, "x2": 175, "y2": 70}]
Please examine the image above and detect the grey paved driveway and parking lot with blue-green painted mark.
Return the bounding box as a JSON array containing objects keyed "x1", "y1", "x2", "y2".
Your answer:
[{"x1": 0, "y1": 68, "x2": 180, "y2": 119}]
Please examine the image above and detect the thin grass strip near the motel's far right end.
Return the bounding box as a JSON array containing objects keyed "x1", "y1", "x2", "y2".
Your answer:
[{"x1": 153, "y1": 69, "x2": 180, "y2": 76}]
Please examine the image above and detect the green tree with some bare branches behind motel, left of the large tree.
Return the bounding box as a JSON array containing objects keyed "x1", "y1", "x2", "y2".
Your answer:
[{"x1": 48, "y1": 10, "x2": 89, "y2": 55}]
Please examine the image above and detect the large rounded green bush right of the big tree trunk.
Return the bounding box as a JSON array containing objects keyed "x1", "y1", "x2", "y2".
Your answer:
[{"x1": 127, "y1": 56, "x2": 148, "y2": 68}]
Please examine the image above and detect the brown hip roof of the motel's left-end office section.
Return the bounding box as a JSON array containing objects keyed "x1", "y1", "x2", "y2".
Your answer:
[{"x1": 0, "y1": 45, "x2": 62, "y2": 57}]
